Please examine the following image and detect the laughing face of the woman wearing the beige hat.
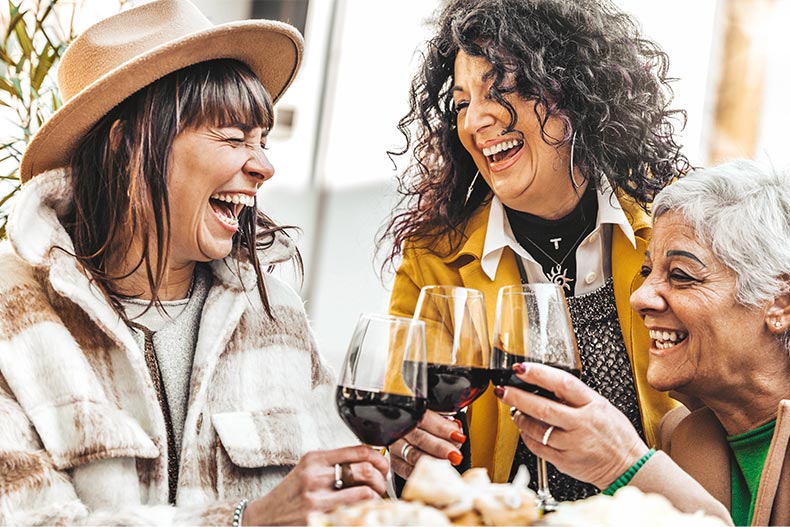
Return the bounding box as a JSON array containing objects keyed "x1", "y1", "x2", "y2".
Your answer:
[{"x1": 168, "y1": 127, "x2": 274, "y2": 265}]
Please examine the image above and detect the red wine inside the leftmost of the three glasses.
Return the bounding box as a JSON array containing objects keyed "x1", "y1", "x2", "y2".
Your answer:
[{"x1": 335, "y1": 386, "x2": 426, "y2": 447}]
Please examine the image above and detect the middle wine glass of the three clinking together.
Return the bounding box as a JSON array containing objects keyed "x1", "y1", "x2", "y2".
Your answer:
[{"x1": 414, "y1": 285, "x2": 490, "y2": 417}]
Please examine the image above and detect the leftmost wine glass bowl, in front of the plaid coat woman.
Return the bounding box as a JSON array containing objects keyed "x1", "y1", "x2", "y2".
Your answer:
[{"x1": 335, "y1": 314, "x2": 427, "y2": 449}]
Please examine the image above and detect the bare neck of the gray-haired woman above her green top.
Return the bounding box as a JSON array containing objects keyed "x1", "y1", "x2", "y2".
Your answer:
[{"x1": 700, "y1": 366, "x2": 790, "y2": 435}]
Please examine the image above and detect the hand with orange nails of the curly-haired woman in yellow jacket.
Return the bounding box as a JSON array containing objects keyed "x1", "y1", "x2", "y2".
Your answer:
[{"x1": 389, "y1": 410, "x2": 466, "y2": 479}]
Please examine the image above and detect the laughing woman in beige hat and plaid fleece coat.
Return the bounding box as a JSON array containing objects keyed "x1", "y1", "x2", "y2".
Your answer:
[{"x1": 0, "y1": 0, "x2": 389, "y2": 525}]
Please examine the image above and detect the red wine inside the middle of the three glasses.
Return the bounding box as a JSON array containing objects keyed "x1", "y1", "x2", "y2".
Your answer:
[{"x1": 403, "y1": 361, "x2": 491, "y2": 414}]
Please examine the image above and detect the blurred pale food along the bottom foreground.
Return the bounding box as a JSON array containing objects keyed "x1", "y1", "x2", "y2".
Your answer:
[{"x1": 308, "y1": 456, "x2": 724, "y2": 527}]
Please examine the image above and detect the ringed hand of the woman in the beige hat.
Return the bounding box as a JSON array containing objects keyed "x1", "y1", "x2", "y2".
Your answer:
[{"x1": 242, "y1": 445, "x2": 389, "y2": 525}]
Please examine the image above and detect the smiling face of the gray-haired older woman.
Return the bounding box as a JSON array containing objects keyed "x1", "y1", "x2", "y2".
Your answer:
[{"x1": 631, "y1": 212, "x2": 777, "y2": 397}]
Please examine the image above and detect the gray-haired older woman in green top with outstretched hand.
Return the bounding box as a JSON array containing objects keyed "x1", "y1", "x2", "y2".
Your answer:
[{"x1": 496, "y1": 160, "x2": 790, "y2": 525}]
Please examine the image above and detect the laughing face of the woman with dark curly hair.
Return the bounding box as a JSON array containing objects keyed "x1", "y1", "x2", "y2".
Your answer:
[{"x1": 452, "y1": 51, "x2": 581, "y2": 219}]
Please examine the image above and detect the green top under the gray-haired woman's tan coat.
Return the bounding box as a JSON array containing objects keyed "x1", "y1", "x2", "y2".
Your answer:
[{"x1": 727, "y1": 419, "x2": 776, "y2": 525}]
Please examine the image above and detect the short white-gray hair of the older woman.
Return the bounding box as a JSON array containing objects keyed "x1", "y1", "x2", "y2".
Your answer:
[{"x1": 653, "y1": 159, "x2": 790, "y2": 306}]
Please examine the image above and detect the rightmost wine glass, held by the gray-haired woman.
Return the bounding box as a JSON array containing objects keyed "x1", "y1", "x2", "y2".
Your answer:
[{"x1": 491, "y1": 283, "x2": 581, "y2": 512}]
